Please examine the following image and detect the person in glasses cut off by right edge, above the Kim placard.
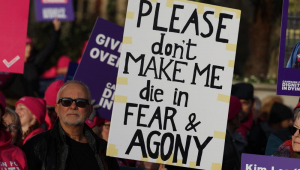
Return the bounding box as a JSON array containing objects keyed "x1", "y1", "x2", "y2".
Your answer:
[{"x1": 274, "y1": 105, "x2": 300, "y2": 158}]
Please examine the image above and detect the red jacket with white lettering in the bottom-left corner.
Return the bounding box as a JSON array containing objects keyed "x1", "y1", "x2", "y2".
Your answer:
[{"x1": 0, "y1": 130, "x2": 28, "y2": 170}]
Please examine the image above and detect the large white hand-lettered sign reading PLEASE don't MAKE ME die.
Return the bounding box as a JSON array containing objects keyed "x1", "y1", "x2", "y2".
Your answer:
[{"x1": 107, "y1": 0, "x2": 241, "y2": 169}]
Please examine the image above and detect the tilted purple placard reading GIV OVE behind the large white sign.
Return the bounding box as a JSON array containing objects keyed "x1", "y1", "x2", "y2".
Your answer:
[{"x1": 74, "y1": 18, "x2": 124, "y2": 120}]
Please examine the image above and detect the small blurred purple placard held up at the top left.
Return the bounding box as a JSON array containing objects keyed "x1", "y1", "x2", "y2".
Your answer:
[{"x1": 35, "y1": 0, "x2": 74, "y2": 21}]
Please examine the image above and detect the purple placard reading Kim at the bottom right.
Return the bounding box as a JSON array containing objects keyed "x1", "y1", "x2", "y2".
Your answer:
[{"x1": 241, "y1": 154, "x2": 300, "y2": 170}]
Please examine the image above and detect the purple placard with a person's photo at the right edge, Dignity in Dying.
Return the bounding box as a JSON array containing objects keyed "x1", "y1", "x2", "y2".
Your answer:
[{"x1": 277, "y1": 0, "x2": 300, "y2": 96}]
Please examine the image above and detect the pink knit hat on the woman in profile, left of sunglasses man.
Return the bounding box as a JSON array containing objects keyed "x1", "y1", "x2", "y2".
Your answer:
[{"x1": 15, "y1": 96, "x2": 46, "y2": 124}]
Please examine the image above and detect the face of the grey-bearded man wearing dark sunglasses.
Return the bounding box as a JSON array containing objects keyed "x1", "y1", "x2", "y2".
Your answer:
[{"x1": 55, "y1": 83, "x2": 93, "y2": 126}]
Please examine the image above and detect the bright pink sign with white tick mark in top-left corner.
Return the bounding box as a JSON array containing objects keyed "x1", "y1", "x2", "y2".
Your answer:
[{"x1": 0, "y1": 0, "x2": 29, "y2": 73}]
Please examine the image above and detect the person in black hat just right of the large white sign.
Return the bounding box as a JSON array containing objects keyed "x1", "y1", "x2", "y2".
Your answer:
[{"x1": 231, "y1": 83, "x2": 254, "y2": 139}]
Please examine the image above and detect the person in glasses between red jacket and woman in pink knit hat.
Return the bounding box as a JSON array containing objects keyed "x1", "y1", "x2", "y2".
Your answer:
[{"x1": 2, "y1": 107, "x2": 22, "y2": 147}]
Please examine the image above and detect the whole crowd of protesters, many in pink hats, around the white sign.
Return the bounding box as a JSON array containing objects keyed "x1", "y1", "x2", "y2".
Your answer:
[{"x1": 0, "y1": 19, "x2": 300, "y2": 170}]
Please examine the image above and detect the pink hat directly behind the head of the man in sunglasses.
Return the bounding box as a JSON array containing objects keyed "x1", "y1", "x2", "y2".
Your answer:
[{"x1": 44, "y1": 80, "x2": 65, "y2": 106}]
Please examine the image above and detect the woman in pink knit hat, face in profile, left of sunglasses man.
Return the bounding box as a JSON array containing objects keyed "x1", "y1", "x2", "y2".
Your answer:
[{"x1": 15, "y1": 96, "x2": 46, "y2": 145}]
